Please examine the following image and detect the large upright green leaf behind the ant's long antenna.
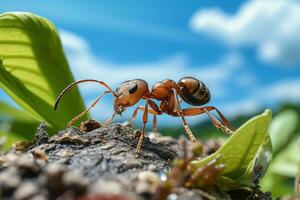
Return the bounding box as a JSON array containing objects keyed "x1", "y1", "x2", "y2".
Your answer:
[{"x1": 0, "y1": 12, "x2": 84, "y2": 129}]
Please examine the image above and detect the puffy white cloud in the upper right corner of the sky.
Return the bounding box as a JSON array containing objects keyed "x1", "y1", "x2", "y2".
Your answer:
[{"x1": 190, "y1": 0, "x2": 300, "y2": 66}]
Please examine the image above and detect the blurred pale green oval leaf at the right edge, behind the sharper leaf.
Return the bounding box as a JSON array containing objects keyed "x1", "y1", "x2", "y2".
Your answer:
[{"x1": 270, "y1": 110, "x2": 299, "y2": 154}]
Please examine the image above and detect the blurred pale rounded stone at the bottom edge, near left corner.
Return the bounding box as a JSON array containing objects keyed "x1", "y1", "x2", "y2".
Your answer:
[{"x1": 13, "y1": 181, "x2": 39, "y2": 200}]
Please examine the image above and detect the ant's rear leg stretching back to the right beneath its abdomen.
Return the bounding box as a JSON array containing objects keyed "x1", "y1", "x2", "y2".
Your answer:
[{"x1": 183, "y1": 106, "x2": 233, "y2": 135}]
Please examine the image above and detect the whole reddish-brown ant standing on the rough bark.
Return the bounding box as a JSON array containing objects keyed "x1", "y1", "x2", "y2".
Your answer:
[{"x1": 54, "y1": 77, "x2": 233, "y2": 154}]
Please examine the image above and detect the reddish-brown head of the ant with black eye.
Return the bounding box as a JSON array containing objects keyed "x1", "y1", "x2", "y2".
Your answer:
[{"x1": 114, "y1": 79, "x2": 149, "y2": 114}]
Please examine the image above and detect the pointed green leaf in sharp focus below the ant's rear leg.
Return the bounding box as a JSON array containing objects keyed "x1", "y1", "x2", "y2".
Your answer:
[{"x1": 192, "y1": 110, "x2": 272, "y2": 189}]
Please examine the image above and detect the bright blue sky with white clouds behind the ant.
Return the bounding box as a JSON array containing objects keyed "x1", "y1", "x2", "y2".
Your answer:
[{"x1": 0, "y1": 0, "x2": 300, "y2": 126}]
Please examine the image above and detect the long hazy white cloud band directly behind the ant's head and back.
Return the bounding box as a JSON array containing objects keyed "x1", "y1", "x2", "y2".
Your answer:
[{"x1": 60, "y1": 31, "x2": 242, "y2": 97}]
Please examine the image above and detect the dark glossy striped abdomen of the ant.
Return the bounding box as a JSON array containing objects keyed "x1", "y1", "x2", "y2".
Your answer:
[{"x1": 178, "y1": 77, "x2": 210, "y2": 106}]
